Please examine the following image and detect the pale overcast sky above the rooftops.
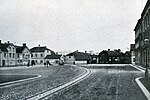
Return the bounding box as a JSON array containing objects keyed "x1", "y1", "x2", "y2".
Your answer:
[{"x1": 0, "y1": 0, "x2": 147, "y2": 52}]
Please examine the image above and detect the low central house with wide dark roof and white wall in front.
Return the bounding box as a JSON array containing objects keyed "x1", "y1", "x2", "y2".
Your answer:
[{"x1": 64, "y1": 51, "x2": 91, "y2": 64}]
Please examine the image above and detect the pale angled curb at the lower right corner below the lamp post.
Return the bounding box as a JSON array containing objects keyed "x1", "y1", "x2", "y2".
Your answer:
[{"x1": 135, "y1": 77, "x2": 150, "y2": 100}]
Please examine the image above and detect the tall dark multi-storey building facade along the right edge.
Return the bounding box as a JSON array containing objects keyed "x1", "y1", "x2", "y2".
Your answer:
[{"x1": 134, "y1": 0, "x2": 150, "y2": 66}]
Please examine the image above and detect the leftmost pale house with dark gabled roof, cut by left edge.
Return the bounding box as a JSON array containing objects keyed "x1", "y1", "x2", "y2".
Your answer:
[{"x1": 0, "y1": 40, "x2": 16, "y2": 66}]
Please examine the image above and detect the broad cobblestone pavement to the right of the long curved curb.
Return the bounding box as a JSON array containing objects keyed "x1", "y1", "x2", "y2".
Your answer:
[{"x1": 48, "y1": 65, "x2": 146, "y2": 100}]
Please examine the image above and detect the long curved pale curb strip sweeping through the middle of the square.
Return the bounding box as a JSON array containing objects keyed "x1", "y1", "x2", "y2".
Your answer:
[{"x1": 26, "y1": 68, "x2": 91, "y2": 100}]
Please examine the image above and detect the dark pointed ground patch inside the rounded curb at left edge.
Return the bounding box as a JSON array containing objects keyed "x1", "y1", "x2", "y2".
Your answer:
[{"x1": 0, "y1": 75, "x2": 37, "y2": 84}]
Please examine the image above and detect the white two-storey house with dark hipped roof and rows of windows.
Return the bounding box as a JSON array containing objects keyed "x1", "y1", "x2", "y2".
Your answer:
[{"x1": 30, "y1": 45, "x2": 55, "y2": 64}]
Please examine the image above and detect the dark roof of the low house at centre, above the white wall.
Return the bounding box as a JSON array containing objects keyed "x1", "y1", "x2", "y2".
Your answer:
[{"x1": 66, "y1": 51, "x2": 91, "y2": 61}]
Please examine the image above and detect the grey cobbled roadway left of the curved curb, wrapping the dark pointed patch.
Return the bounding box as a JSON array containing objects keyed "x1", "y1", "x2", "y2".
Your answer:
[{"x1": 0, "y1": 65, "x2": 84, "y2": 100}]
